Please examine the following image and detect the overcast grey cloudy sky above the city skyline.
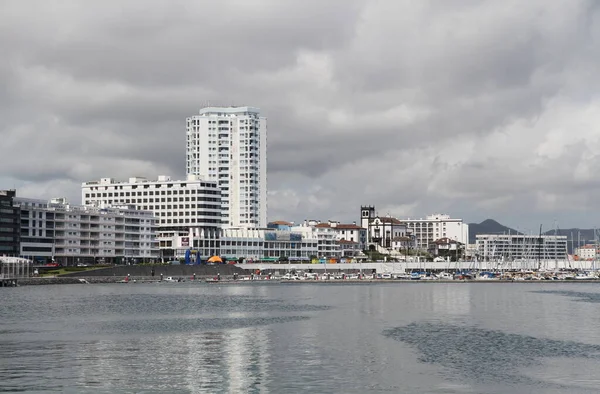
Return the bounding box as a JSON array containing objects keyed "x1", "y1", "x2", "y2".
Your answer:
[{"x1": 0, "y1": 0, "x2": 600, "y2": 230}]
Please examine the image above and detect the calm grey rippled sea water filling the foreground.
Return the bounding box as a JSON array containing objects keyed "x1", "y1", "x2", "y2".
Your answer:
[{"x1": 0, "y1": 282, "x2": 600, "y2": 394}]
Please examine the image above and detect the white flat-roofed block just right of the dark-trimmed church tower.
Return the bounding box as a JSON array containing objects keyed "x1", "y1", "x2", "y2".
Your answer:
[{"x1": 400, "y1": 214, "x2": 469, "y2": 250}]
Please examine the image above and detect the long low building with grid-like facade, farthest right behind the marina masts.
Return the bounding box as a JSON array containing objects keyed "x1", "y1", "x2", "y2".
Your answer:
[{"x1": 476, "y1": 234, "x2": 568, "y2": 261}]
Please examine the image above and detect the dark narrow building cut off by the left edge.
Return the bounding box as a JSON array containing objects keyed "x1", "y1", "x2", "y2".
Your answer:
[{"x1": 0, "y1": 190, "x2": 20, "y2": 256}]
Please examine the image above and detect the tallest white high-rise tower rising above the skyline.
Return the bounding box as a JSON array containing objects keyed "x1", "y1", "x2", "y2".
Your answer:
[{"x1": 186, "y1": 107, "x2": 267, "y2": 228}]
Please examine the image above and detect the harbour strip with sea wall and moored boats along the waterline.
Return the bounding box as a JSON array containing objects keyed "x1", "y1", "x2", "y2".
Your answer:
[{"x1": 0, "y1": 254, "x2": 600, "y2": 287}]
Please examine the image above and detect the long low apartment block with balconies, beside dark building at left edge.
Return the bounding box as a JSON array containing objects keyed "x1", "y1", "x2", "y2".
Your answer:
[{"x1": 13, "y1": 197, "x2": 159, "y2": 265}]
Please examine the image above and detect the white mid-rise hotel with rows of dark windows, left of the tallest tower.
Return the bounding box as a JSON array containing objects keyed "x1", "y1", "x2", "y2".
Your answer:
[{"x1": 81, "y1": 175, "x2": 222, "y2": 259}]
